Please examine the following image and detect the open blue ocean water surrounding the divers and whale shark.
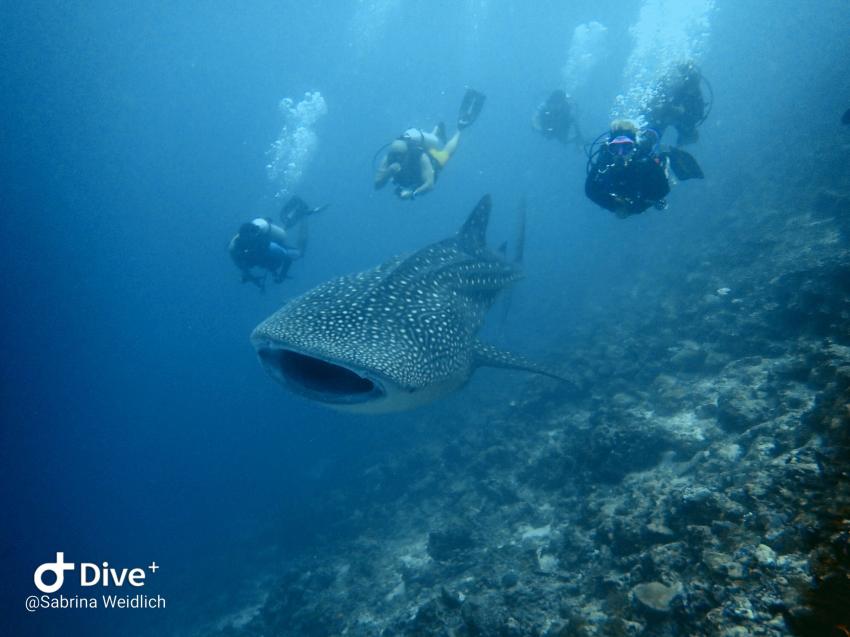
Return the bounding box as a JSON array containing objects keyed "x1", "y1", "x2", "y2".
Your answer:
[{"x1": 0, "y1": 0, "x2": 850, "y2": 635}]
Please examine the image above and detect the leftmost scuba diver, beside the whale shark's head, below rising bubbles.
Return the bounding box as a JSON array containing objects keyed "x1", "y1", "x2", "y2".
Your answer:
[{"x1": 228, "y1": 196, "x2": 327, "y2": 291}]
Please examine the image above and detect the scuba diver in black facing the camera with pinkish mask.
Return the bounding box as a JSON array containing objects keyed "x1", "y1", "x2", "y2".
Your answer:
[{"x1": 584, "y1": 120, "x2": 703, "y2": 218}]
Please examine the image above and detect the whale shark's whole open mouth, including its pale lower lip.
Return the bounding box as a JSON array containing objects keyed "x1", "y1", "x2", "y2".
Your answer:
[{"x1": 257, "y1": 347, "x2": 385, "y2": 404}]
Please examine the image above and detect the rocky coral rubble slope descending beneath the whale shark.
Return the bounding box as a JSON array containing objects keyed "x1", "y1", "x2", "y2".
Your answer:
[{"x1": 205, "y1": 137, "x2": 850, "y2": 636}]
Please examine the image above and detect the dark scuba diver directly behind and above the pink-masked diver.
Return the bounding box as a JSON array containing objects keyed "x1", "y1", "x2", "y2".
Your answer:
[{"x1": 644, "y1": 62, "x2": 713, "y2": 145}]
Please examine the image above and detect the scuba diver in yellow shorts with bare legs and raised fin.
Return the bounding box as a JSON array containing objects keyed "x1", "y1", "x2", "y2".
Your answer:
[{"x1": 374, "y1": 89, "x2": 486, "y2": 200}]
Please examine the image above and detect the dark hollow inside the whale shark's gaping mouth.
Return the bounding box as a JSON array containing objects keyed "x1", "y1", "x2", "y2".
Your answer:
[{"x1": 259, "y1": 348, "x2": 376, "y2": 396}]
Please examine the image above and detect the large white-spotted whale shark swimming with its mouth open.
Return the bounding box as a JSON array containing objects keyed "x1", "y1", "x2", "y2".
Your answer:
[{"x1": 251, "y1": 195, "x2": 563, "y2": 413}]
